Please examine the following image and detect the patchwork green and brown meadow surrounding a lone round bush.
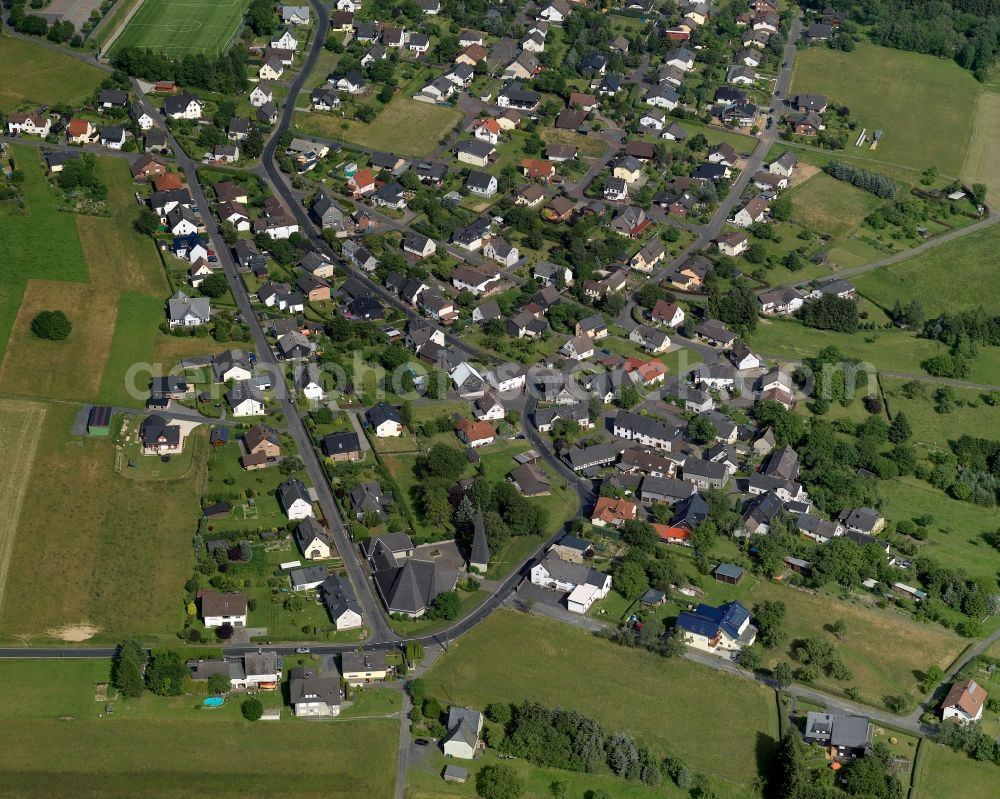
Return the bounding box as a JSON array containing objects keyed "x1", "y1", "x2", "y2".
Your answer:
[{"x1": 0, "y1": 150, "x2": 168, "y2": 405}]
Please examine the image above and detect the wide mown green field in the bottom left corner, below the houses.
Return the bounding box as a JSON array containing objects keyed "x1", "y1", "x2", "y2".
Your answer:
[{"x1": 0, "y1": 661, "x2": 399, "y2": 799}]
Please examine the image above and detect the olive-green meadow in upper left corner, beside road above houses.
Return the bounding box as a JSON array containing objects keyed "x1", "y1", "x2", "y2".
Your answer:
[{"x1": 0, "y1": 35, "x2": 104, "y2": 112}]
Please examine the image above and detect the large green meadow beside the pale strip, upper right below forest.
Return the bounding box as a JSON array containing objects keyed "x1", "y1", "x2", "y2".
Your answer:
[{"x1": 789, "y1": 44, "x2": 976, "y2": 175}]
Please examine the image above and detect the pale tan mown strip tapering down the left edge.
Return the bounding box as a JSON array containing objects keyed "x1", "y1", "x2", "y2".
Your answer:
[{"x1": 0, "y1": 399, "x2": 46, "y2": 607}]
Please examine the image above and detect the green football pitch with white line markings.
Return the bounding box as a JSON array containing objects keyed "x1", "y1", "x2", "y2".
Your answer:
[{"x1": 111, "y1": 0, "x2": 250, "y2": 56}]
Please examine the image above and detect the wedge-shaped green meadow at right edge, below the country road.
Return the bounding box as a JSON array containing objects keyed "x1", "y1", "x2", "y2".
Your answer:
[{"x1": 854, "y1": 225, "x2": 1000, "y2": 317}]
